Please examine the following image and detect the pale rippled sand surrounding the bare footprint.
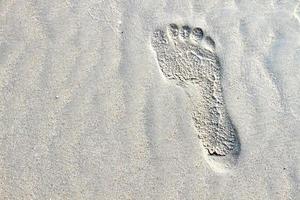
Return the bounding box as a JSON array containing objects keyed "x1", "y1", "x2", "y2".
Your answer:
[{"x1": 0, "y1": 0, "x2": 300, "y2": 200}]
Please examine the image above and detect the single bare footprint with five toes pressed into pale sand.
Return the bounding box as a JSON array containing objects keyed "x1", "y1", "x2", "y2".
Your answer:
[{"x1": 151, "y1": 24, "x2": 240, "y2": 172}]
